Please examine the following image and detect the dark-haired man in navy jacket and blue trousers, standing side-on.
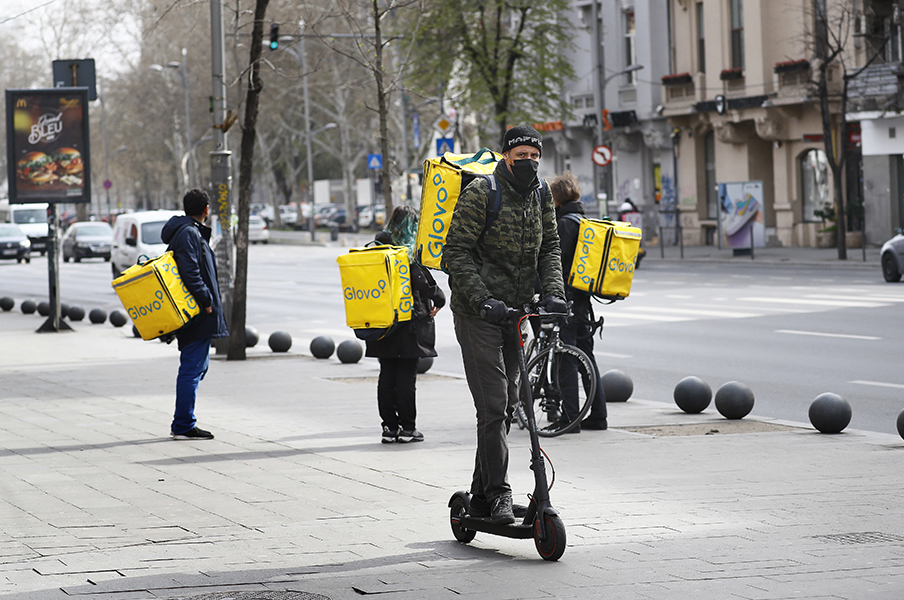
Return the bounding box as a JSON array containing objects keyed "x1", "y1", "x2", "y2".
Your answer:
[{"x1": 160, "y1": 189, "x2": 229, "y2": 440}]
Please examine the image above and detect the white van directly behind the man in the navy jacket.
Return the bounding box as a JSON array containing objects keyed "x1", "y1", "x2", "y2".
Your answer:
[{"x1": 110, "y1": 210, "x2": 185, "y2": 279}]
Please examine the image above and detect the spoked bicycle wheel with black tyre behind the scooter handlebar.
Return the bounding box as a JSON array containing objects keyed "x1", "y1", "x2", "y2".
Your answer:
[{"x1": 527, "y1": 344, "x2": 597, "y2": 437}]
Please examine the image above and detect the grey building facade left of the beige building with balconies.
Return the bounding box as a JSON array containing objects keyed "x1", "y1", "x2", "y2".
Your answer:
[{"x1": 538, "y1": 0, "x2": 677, "y2": 239}]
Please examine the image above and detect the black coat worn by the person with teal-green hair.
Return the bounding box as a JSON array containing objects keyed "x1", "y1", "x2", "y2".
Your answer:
[{"x1": 365, "y1": 232, "x2": 446, "y2": 358}]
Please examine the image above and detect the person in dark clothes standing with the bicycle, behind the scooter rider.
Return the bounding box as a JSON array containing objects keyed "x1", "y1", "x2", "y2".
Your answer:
[{"x1": 549, "y1": 171, "x2": 608, "y2": 433}]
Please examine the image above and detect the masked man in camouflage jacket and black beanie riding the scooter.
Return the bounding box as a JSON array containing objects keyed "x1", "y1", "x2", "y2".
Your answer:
[{"x1": 443, "y1": 124, "x2": 567, "y2": 524}]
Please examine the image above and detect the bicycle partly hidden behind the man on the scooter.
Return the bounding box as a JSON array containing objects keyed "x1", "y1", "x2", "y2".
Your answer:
[{"x1": 515, "y1": 306, "x2": 598, "y2": 437}]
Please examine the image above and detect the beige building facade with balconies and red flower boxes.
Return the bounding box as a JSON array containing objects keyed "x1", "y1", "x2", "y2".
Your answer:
[{"x1": 662, "y1": 0, "x2": 856, "y2": 246}]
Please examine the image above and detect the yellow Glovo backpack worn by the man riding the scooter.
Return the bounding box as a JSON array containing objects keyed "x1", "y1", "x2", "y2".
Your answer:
[{"x1": 414, "y1": 148, "x2": 502, "y2": 269}]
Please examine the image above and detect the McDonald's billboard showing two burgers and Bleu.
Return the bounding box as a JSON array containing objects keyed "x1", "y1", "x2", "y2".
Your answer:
[{"x1": 6, "y1": 88, "x2": 91, "y2": 204}]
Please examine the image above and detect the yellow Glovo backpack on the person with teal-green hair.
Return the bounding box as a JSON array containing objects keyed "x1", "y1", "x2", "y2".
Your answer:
[{"x1": 336, "y1": 245, "x2": 413, "y2": 340}]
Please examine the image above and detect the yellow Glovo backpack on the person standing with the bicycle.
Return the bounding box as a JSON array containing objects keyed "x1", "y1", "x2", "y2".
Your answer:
[{"x1": 568, "y1": 213, "x2": 642, "y2": 300}]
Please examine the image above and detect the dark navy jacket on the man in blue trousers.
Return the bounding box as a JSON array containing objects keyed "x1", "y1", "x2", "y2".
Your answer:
[{"x1": 160, "y1": 215, "x2": 229, "y2": 350}]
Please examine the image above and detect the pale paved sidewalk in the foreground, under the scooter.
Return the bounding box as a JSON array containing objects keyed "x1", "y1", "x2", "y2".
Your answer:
[{"x1": 0, "y1": 304, "x2": 904, "y2": 600}]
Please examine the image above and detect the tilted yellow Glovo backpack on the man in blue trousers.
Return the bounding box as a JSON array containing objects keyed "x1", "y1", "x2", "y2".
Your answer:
[{"x1": 113, "y1": 251, "x2": 201, "y2": 340}]
